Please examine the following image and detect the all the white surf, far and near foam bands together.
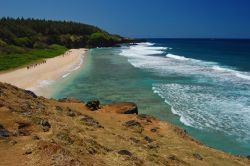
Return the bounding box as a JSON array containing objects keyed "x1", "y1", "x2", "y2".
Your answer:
[{"x1": 120, "y1": 44, "x2": 250, "y2": 141}]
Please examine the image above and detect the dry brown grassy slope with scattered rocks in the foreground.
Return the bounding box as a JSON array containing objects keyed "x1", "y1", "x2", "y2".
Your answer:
[{"x1": 0, "y1": 83, "x2": 250, "y2": 166}]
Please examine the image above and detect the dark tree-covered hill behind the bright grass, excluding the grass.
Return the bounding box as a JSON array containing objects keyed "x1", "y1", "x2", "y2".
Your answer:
[{"x1": 0, "y1": 18, "x2": 135, "y2": 48}]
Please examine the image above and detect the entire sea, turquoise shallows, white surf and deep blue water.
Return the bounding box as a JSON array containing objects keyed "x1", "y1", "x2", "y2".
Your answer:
[{"x1": 52, "y1": 39, "x2": 250, "y2": 155}]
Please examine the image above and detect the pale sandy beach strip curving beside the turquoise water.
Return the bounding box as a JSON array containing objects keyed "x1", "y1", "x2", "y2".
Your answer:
[{"x1": 0, "y1": 48, "x2": 87, "y2": 97}]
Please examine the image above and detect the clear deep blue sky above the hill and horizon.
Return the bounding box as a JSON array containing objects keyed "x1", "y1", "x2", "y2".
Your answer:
[{"x1": 0, "y1": 0, "x2": 250, "y2": 38}]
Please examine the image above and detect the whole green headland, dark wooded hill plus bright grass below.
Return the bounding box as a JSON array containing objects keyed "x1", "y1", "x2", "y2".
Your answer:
[{"x1": 0, "y1": 17, "x2": 139, "y2": 71}]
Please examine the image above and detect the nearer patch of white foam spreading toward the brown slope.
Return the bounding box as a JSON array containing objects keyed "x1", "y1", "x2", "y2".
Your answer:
[{"x1": 153, "y1": 84, "x2": 250, "y2": 141}]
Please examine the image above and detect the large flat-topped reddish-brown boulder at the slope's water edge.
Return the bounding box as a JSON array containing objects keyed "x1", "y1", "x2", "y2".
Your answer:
[{"x1": 99, "y1": 102, "x2": 138, "y2": 114}]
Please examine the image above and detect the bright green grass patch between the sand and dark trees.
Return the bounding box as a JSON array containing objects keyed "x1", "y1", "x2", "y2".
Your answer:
[{"x1": 0, "y1": 45, "x2": 67, "y2": 71}]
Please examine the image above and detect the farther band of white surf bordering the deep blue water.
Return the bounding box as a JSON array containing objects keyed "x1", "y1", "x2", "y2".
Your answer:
[{"x1": 120, "y1": 43, "x2": 250, "y2": 84}]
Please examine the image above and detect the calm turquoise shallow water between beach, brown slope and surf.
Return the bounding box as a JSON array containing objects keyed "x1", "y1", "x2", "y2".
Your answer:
[{"x1": 53, "y1": 44, "x2": 249, "y2": 156}]
